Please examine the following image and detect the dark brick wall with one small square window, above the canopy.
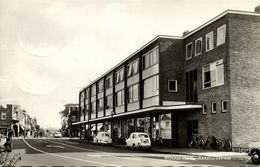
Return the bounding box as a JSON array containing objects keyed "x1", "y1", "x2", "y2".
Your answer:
[{"x1": 159, "y1": 39, "x2": 185, "y2": 102}]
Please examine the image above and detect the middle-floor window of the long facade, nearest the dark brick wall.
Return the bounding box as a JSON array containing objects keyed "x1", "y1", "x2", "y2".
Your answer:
[{"x1": 143, "y1": 75, "x2": 159, "y2": 98}]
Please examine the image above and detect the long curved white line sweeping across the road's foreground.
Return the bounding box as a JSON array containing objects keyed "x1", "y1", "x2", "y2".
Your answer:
[{"x1": 23, "y1": 139, "x2": 122, "y2": 167}]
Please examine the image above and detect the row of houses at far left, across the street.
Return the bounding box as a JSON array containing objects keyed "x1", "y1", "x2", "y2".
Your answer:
[{"x1": 0, "y1": 104, "x2": 40, "y2": 137}]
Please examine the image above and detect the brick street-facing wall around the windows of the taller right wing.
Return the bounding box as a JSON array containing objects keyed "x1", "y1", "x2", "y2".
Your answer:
[{"x1": 178, "y1": 16, "x2": 232, "y2": 146}]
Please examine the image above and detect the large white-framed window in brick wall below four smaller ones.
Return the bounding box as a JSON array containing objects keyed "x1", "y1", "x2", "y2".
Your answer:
[{"x1": 202, "y1": 59, "x2": 224, "y2": 89}]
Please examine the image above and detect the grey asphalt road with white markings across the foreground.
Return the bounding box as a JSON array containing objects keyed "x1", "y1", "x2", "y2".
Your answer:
[{"x1": 8, "y1": 139, "x2": 250, "y2": 166}]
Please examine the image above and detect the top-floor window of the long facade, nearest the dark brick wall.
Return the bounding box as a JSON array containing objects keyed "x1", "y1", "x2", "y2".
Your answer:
[{"x1": 143, "y1": 47, "x2": 159, "y2": 69}]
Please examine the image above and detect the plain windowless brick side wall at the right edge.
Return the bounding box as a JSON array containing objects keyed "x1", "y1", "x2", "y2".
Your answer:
[{"x1": 229, "y1": 14, "x2": 260, "y2": 147}]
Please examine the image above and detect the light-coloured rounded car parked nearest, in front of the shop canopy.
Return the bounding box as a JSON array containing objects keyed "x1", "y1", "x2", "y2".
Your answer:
[{"x1": 126, "y1": 132, "x2": 151, "y2": 149}]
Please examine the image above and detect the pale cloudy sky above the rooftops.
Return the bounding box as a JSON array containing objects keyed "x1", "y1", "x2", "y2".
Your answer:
[{"x1": 0, "y1": 0, "x2": 260, "y2": 128}]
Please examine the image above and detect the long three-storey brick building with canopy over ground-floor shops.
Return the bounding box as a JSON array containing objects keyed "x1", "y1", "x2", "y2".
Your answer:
[{"x1": 74, "y1": 8, "x2": 260, "y2": 147}]
